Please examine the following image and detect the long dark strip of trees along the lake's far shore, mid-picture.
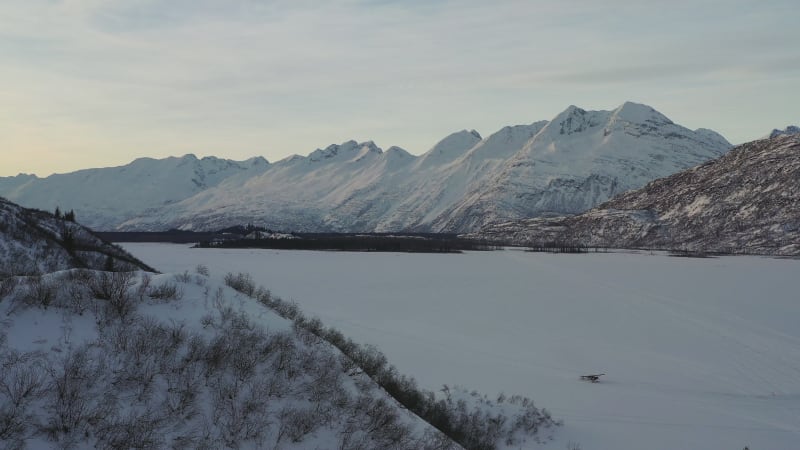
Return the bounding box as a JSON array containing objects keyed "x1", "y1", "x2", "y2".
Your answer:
[{"x1": 198, "y1": 233, "x2": 500, "y2": 253}]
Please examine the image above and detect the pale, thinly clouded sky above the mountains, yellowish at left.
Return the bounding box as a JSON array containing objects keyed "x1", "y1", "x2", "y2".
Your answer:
[{"x1": 0, "y1": 0, "x2": 800, "y2": 176}]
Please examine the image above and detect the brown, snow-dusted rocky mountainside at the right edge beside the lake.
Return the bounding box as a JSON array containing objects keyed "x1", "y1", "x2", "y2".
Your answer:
[{"x1": 476, "y1": 134, "x2": 800, "y2": 255}]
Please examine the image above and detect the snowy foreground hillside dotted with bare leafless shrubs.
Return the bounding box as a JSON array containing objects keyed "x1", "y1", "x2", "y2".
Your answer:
[{"x1": 0, "y1": 267, "x2": 555, "y2": 449}]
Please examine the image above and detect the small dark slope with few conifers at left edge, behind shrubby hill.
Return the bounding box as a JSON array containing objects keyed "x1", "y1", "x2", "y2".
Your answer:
[{"x1": 0, "y1": 198, "x2": 153, "y2": 277}]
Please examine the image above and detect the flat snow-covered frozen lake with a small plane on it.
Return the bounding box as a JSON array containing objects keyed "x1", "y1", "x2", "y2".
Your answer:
[{"x1": 124, "y1": 244, "x2": 800, "y2": 450}]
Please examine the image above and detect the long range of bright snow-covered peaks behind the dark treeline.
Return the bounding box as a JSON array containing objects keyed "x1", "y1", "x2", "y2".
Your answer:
[{"x1": 0, "y1": 102, "x2": 730, "y2": 232}]
